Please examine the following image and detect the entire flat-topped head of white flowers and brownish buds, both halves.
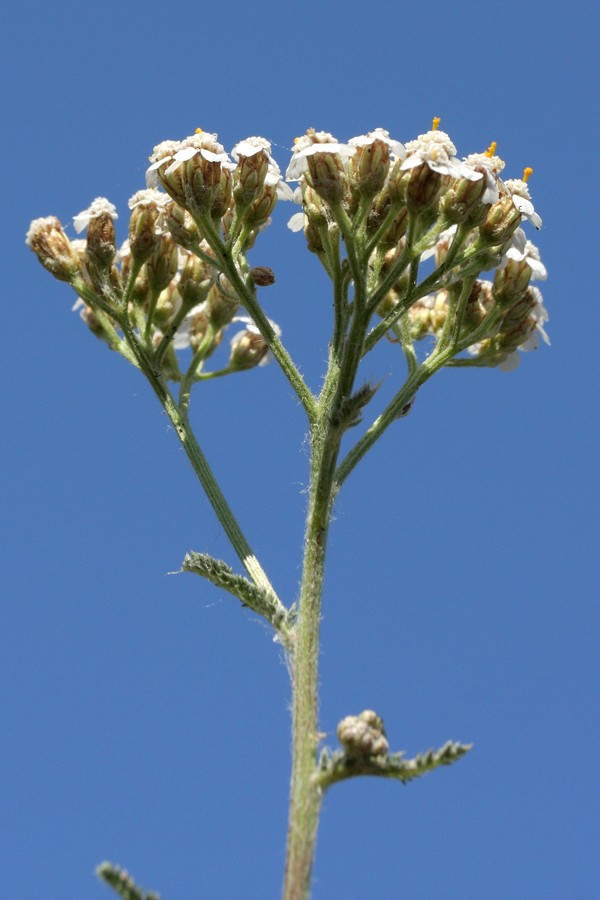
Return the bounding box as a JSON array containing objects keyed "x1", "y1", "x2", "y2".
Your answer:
[{"x1": 27, "y1": 120, "x2": 547, "y2": 390}]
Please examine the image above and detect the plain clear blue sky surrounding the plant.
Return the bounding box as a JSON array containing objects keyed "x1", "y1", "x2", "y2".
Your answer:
[{"x1": 0, "y1": 0, "x2": 600, "y2": 900}]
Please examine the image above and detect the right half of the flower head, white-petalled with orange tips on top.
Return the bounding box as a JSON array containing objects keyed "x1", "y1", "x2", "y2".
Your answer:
[{"x1": 287, "y1": 119, "x2": 548, "y2": 368}]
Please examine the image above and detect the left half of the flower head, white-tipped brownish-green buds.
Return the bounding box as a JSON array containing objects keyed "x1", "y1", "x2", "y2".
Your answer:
[{"x1": 27, "y1": 132, "x2": 292, "y2": 390}]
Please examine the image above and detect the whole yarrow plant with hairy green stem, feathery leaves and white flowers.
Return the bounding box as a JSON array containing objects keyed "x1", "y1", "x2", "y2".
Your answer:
[{"x1": 27, "y1": 119, "x2": 548, "y2": 900}]
